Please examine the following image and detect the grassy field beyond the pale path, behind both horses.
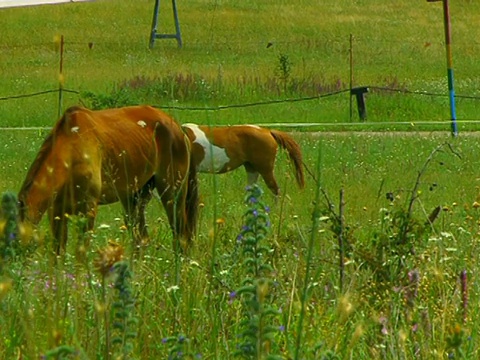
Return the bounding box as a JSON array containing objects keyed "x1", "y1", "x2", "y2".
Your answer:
[{"x1": 0, "y1": 0, "x2": 480, "y2": 130}]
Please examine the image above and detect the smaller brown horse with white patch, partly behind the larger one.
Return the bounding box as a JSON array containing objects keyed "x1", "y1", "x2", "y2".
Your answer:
[{"x1": 182, "y1": 124, "x2": 305, "y2": 195}]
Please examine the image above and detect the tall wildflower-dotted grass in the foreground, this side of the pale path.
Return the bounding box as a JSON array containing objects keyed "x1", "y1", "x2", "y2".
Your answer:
[{"x1": 0, "y1": 130, "x2": 479, "y2": 359}]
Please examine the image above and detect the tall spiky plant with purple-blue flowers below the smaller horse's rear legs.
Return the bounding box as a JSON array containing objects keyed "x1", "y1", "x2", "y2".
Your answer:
[{"x1": 235, "y1": 185, "x2": 280, "y2": 359}]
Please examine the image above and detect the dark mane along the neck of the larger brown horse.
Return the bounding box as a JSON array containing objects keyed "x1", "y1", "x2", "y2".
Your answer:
[{"x1": 20, "y1": 106, "x2": 81, "y2": 197}]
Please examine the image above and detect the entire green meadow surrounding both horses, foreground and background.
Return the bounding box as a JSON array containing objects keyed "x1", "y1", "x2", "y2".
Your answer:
[{"x1": 0, "y1": 0, "x2": 480, "y2": 360}]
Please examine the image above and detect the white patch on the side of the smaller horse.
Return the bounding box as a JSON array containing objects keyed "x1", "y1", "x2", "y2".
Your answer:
[{"x1": 183, "y1": 124, "x2": 230, "y2": 173}]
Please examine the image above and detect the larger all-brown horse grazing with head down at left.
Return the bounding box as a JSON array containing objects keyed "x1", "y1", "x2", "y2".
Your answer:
[{"x1": 18, "y1": 106, "x2": 198, "y2": 253}]
